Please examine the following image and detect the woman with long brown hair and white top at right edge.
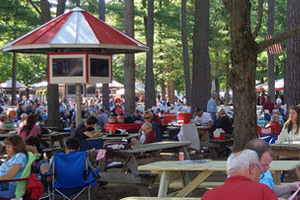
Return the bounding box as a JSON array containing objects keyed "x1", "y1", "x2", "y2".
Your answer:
[{"x1": 275, "y1": 106, "x2": 300, "y2": 144}]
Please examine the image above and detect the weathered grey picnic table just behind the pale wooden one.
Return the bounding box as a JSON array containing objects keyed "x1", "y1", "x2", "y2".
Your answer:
[{"x1": 91, "y1": 141, "x2": 190, "y2": 196}]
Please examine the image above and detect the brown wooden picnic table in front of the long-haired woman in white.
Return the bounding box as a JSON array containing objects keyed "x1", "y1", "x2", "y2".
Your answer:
[{"x1": 270, "y1": 141, "x2": 300, "y2": 160}]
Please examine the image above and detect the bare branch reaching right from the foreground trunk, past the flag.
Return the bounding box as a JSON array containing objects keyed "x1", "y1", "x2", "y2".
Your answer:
[{"x1": 257, "y1": 26, "x2": 300, "y2": 53}]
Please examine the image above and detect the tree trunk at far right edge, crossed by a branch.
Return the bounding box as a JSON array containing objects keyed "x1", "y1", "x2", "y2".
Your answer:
[{"x1": 284, "y1": 0, "x2": 300, "y2": 105}]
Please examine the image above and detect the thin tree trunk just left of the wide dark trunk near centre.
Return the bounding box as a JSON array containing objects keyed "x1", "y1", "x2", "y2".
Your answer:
[{"x1": 180, "y1": 0, "x2": 191, "y2": 106}]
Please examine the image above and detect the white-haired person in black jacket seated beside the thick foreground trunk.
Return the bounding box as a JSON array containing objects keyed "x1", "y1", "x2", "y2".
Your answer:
[{"x1": 213, "y1": 108, "x2": 232, "y2": 135}]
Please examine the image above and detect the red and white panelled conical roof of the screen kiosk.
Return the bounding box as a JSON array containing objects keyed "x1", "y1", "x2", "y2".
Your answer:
[{"x1": 3, "y1": 7, "x2": 149, "y2": 53}]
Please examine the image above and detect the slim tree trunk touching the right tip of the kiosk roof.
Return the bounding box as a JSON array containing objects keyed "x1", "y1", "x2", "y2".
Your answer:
[{"x1": 145, "y1": 0, "x2": 156, "y2": 109}]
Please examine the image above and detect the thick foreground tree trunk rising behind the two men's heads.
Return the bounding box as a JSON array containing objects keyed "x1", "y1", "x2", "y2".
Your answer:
[{"x1": 223, "y1": 0, "x2": 257, "y2": 150}]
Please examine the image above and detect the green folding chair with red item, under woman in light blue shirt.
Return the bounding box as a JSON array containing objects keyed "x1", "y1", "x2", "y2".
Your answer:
[{"x1": 0, "y1": 152, "x2": 43, "y2": 199}]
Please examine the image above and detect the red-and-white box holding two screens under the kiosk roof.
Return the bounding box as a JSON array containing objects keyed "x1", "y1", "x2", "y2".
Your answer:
[{"x1": 48, "y1": 52, "x2": 112, "y2": 84}]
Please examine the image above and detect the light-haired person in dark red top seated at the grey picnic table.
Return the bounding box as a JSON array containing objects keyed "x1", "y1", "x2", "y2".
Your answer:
[{"x1": 130, "y1": 122, "x2": 156, "y2": 146}]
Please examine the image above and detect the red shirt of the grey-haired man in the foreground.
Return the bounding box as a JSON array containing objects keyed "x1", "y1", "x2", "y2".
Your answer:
[{"x1": 201, "y1": 176, "x2": 278, "y2": 200}]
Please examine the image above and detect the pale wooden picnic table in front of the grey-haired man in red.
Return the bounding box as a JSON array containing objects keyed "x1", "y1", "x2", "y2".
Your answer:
[{"x1": 138, "y1": 160, "x2": 300, "y2": 197}]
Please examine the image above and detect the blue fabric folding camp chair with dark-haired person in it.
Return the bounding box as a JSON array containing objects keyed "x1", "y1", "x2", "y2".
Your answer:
[{"x1": 51, "y1": 152, "x2": 97, "y2": 200}]
